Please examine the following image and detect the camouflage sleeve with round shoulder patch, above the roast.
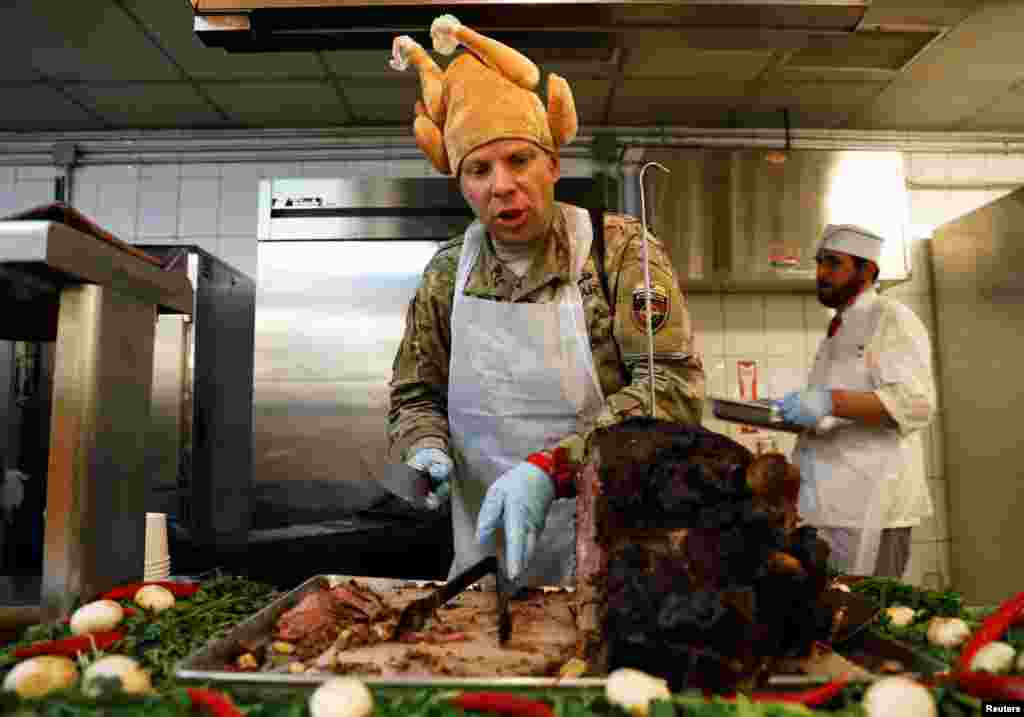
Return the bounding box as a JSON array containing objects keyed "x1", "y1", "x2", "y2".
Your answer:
[{"x1": 559, "y1": 214, "x2": 705, "y2": 479}]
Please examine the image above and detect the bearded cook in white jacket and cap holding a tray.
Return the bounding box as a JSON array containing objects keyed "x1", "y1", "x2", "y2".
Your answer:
[{"x1": 780, "y1": 224, "x2": 935, "y2": 578}]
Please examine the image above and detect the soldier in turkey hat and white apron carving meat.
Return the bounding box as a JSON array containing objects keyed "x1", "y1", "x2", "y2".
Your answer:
[{"x1": 388, "y1": 15, "x2": 705, "y2": 585}]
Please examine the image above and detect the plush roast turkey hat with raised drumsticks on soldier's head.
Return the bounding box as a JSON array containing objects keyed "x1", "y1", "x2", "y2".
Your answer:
[{"x1": 391, "y1": 15, "x2": 578, "y2": 175}]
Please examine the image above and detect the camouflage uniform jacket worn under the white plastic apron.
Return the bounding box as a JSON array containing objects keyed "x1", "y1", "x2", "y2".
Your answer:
[{"x1": 388, "y1": 201, "x2": 705, "y2": 460}]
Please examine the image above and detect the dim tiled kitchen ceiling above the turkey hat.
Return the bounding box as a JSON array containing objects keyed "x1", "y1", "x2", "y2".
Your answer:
[{"x1": 0, "y1": 0, "x2": 1024, "y2": 135}]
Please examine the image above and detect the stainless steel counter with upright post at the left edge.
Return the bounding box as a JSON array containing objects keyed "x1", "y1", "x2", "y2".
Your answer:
[{"x1": 0, "y1": 220, "x2": 194, "y2": 620}]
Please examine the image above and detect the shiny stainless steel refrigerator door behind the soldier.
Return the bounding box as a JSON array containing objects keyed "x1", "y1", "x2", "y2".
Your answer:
[{"x1": 253, "y1": 241, "x2": 438, "y2": 529}]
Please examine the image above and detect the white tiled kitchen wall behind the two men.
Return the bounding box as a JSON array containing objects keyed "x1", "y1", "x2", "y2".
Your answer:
[{"x1": 0, "y1": 147, "x2": 1024, "y2": 587}]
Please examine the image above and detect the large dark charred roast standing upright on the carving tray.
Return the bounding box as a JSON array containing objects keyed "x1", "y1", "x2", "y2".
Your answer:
[{"x1": 577, "y1": 419, "x2": 830, "y2": 688}]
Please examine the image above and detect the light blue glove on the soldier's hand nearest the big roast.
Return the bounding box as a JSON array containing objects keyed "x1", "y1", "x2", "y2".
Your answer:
[{"x1": 476, "y1": 461, "x2": 555, "y2": 580}]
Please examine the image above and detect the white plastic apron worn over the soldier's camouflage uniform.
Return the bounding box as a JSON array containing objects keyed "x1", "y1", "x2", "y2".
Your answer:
[{"x1": 449, "y1": 205, "x2": 604, "y2": 585}]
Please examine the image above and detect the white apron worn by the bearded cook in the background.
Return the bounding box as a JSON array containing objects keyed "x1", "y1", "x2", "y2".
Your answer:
[{"x1": 795, "y1": 292, "x2": 904, "y2": 575}]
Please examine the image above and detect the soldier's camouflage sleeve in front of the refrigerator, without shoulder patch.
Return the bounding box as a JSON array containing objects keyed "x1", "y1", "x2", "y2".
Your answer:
[{"x1": 387, "y1": 239, "x2": 462, "y2": 461}]
